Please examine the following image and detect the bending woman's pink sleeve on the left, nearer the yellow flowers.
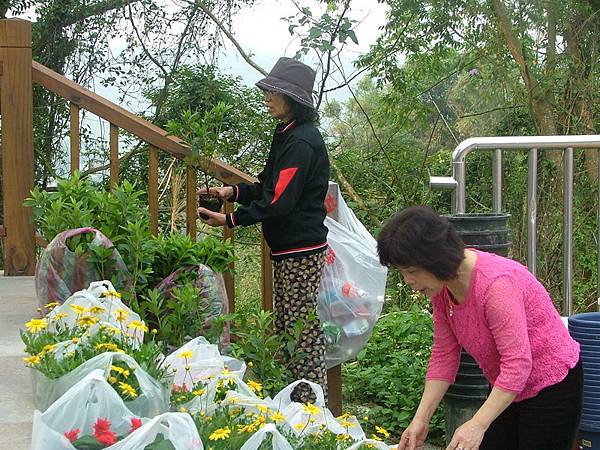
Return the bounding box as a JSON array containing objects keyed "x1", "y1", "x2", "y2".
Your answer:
[{"x1": 425, "y1": 298, "x2": 460, "y2": 383}]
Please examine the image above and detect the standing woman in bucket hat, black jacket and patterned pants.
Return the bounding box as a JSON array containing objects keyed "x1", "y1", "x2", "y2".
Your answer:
[{"x1": 198, "y1": 58, "x2": 329, "y2": 403}]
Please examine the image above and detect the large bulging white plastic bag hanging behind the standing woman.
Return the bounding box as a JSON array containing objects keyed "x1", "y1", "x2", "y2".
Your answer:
[{"x1": 318, "y1": 192, "x2": 387, "y2": 368}]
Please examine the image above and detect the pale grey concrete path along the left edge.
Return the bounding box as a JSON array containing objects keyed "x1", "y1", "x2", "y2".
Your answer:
[{"x1": 0, "y1": 275, "x2": 38, "y2": 450}]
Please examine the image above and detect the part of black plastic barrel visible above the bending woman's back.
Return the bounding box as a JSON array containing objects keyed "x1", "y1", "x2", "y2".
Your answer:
[{"x1": 446, "y1": 213, "x2": 511, "y2": 256}]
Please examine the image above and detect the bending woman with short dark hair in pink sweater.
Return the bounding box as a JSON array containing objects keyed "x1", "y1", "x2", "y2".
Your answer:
[{"x1": 378, "y1": 206, "x2": 583, "y2": 450}]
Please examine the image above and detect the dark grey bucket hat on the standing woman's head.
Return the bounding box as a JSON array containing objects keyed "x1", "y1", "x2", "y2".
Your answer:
[{"x1": 256, "y1": 57, "x2": 316, "y2": 108}]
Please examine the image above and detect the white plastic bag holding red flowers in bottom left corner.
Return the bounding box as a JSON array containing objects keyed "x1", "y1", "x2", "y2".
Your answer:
[{"x1": 31, "y1": 370, "x2": 203, "y2": 450}]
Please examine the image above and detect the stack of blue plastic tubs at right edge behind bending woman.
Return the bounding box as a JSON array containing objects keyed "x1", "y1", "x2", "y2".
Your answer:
[{"x1": 569, "y1": 312, "x2": 600, "y2": 450}]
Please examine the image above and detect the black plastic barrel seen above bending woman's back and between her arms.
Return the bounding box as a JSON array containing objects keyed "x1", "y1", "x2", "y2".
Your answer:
[{"x1": 444, "y1": 213, "x2": 511, "y2": 443}]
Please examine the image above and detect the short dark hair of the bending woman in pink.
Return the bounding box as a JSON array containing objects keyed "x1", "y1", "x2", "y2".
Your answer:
[{"x1": 377, "y1": 206, "x2": 465, "y2": 280}]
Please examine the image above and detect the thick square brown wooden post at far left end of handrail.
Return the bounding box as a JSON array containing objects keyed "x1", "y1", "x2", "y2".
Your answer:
[{"x1": 0, "y1": 19, "x2": 35, "y2": 276}]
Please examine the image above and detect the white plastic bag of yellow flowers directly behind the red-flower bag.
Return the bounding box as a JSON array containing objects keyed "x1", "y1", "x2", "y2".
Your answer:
[{"x1": 31, "y1": 352, "x2": 170, "y2": 417}]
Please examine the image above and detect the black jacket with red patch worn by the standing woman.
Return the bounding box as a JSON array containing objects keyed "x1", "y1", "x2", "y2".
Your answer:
[{"x1": 226, "y1": 122, "x2": 329, "y2": 259}]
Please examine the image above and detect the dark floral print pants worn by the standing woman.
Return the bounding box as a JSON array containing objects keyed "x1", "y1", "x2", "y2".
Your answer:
[{"x1": 273, "y1": 252, "x2": 327, "y2": 403}]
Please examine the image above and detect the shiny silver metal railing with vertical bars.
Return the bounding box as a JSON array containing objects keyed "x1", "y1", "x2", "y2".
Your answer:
[{"x1": 429, "y1": 135, "x2": 600, "y2": 315}]
